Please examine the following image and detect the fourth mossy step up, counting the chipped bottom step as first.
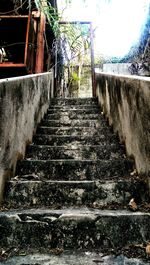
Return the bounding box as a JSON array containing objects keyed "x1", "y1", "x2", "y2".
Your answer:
[{"x1": 26, "y1": 143, "x2": 125, "y2": 160}]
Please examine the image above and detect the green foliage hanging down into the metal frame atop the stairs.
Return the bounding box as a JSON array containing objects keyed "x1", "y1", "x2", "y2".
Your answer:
[{"x1": 36, "y1": 0, "x2": 90, "y2": 92}]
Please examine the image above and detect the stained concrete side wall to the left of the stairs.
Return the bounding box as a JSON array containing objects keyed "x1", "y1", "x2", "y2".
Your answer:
[{"x1": 0, "y1": 73, "x2": 53, "y2": 201}]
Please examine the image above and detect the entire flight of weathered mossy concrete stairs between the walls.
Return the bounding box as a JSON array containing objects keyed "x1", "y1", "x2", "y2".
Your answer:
[{"x1": 0, "y1": 98, "x2": 150, "y2": 265}]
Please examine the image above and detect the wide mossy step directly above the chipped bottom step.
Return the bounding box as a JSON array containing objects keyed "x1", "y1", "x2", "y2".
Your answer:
[{"x1": 5, "y1": 178, "x2": 148, "y2": 208}]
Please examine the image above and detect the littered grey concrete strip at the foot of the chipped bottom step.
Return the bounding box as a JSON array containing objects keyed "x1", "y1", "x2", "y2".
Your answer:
[{"x1": 0, "y1": 252, "x2": 149, "y2": 265}]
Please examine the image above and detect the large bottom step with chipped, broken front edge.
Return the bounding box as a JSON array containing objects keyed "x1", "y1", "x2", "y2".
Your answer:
[{"x1": 0, "y1": 208, "x2": 150, "y2": 249}]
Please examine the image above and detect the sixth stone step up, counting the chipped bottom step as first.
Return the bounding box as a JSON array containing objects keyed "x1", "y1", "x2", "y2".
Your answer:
[{"x1": 36, "y1": 126, "x2": 115, "y2": 136}]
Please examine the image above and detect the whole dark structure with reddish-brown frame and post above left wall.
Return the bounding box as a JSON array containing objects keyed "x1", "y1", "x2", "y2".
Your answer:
[{"x1": 0, "y1": 0, "x2": 56, "y2": 78}]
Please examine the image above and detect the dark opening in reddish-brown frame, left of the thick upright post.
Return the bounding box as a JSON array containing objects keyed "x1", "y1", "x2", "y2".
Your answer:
[{"x1": 0, "y1": 15, "x2": 36, "y2": 76}]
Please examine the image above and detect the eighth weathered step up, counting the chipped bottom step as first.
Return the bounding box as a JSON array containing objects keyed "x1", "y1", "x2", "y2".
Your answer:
[{"x1": 45, "y1": 112, "x2": 100, "y2": 120}]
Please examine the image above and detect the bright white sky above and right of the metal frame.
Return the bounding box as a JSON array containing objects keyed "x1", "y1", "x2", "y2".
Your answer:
[{"x1": 57, "y1": 0, "x2": 150, "y2": 57}]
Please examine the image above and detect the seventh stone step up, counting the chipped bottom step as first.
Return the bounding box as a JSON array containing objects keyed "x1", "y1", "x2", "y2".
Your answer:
[{"x1": 40, "y1": 118, "x2": 108, "y2": 130}]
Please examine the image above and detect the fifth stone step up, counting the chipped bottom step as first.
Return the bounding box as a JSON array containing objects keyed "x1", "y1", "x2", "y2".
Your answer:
[{"x1": 33, "y1": 134, "x2": 119, "y2": 148}]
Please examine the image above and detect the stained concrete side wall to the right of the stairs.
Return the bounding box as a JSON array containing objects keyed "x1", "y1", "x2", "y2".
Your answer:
[{"x1": 96, "y1": 73, "x2": 150, "y2": 176}]
